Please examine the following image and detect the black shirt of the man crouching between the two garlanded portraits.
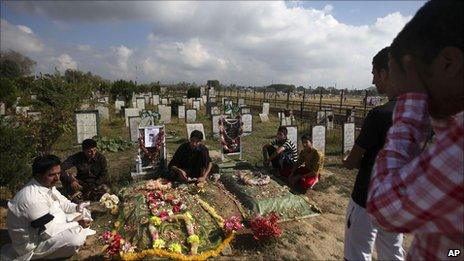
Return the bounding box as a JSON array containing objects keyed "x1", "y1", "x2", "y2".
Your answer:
[{"x1": 169, "y1": 142, "x2": 211, "y2": 178}]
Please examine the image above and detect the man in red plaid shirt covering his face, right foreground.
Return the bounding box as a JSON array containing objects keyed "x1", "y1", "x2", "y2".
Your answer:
[{"x1": 367, "y1": 0, "x2": 464, "y2": 260}]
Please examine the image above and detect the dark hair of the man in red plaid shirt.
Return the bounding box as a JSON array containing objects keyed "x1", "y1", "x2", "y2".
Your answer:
[{"x1": 390, "y1": 0, "x2": 464, "y2": 68}]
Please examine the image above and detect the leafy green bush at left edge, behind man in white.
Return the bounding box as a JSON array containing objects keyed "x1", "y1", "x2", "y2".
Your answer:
[{"x1": 0, "y1": 117, "x2": 37, "y2": 192}]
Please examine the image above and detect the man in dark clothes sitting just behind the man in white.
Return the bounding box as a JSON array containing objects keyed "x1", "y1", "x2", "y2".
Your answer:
[{"x1": 61, "y1": 139, "x2": 109, "y2": 201}]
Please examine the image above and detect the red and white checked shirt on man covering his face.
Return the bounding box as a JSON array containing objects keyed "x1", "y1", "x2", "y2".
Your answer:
[{"x1": 367, "y1": 93, "x2": 464, "y2": 260}]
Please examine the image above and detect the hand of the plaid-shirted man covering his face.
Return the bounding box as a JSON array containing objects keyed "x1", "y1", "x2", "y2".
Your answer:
[{"x1": 387, "y1": 55, "x2": 426, "y2": 96}]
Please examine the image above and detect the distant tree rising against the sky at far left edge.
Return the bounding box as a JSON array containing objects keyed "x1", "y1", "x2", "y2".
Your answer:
[{"x1": 0, "y1": 50, "x2": 37, "y2": 77}]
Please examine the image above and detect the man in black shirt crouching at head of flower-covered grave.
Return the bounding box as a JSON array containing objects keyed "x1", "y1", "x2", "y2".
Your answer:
[{"x1": 168, "y1": 130, "x2": 212, "y2": 185}]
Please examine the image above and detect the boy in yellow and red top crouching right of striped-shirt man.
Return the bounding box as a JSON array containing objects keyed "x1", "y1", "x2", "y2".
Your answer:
[{"x1": 288, "y1": 134, "x2": 324, "y2": 192}]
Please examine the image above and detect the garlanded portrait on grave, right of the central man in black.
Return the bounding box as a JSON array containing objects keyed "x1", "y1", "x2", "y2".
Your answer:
[{"x1": 219, "y1": 116, "x2": 243, "y2": 154}]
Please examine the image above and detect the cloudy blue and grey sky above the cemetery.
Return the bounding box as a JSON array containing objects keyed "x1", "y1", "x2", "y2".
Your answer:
[{"x1": 0, "y1": 0, "x2": 425, "y2": 89}]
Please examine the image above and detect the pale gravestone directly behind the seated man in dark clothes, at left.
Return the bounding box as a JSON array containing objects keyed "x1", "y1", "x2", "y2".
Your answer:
[{"x1": 74, "y1": 110, "x2": 100, "y2": 144}]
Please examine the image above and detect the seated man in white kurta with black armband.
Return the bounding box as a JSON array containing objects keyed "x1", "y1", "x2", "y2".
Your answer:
[{"x1": 1, "y1": 155, "x2": 92, "y2": 260}]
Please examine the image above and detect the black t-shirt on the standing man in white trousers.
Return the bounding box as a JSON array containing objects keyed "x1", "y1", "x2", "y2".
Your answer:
[{"x1": 351, "y1": 99, "x2": 396, "y2": 208}]
